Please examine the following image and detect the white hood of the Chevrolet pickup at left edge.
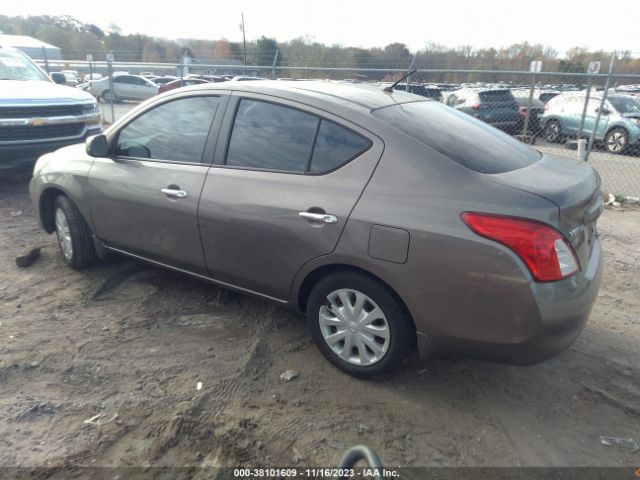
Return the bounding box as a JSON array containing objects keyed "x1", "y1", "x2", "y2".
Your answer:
[{"x1": 0, "y1": 80, "x2": 95, "y2": 106}]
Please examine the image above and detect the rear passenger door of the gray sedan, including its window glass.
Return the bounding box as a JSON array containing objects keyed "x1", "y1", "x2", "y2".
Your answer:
[{"x1": 199, "y1": 93, "x2": 383, "y2": 300}]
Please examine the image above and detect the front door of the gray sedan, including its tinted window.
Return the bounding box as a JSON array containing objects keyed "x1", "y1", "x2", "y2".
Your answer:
[{"x1": 89, "y1": 95, "x2": 226, "y2": 273}]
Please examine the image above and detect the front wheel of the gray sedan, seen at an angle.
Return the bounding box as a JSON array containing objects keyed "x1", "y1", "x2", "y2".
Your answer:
[{"x1": 53, "y1": 195, "x2": 98, "y2": 270}]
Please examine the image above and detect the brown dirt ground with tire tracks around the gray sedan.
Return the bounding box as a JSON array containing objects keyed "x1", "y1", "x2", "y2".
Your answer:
[{"x1": 0, "y1": 173, "x2": 640, "y2": 467}]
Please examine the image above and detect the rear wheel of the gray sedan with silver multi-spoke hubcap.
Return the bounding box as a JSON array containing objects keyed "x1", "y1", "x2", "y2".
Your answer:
[{"x1": 307, "y1": 271, "x2": 415, "y2": 378}]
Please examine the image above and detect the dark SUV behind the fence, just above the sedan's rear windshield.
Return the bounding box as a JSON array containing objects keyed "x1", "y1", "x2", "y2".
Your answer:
[{"x1": 447, "y1": 88, "x2": 520, "y2": 132}]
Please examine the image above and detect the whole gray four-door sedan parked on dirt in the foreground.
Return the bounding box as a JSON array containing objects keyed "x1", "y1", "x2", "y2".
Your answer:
[{"x1": 30, "y1": 81, "x2": 602, "y2": 377}]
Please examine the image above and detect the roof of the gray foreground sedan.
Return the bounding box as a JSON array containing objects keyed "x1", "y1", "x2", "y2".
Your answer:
[{"x1": 184, "y1": 80, "x2": 429, "y2": 110}]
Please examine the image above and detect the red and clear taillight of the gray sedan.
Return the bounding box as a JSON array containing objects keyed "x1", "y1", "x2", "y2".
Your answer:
[{"x1": 461, "y1": 212, "x2": 579, "y2": 282}]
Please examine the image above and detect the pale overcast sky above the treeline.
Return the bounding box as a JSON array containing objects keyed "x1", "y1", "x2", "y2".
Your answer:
[{"x1": 1, "y1": 0, "x2": 640, "y2": 53}]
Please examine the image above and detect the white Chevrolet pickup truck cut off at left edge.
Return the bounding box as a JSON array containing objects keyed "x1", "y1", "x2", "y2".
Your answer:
[{"x1": 0, "y1": 45, "x2": 102, "y2": 172}]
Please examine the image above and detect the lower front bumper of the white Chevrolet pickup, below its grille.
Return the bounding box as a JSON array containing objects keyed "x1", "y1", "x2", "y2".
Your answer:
[{"x1": 0, "y1": 126, "x2": 102, "y2": 172}]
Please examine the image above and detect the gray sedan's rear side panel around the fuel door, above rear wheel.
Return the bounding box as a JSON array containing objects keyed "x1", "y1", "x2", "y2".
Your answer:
[{"x1": 306, "y1": 127, "x2": 557, "y2": 343}]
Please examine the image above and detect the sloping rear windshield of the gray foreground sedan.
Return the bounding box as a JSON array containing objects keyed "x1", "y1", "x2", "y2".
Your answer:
[{"x1": 372, "y1": 101, "x2": 542, "y2": 173}]
